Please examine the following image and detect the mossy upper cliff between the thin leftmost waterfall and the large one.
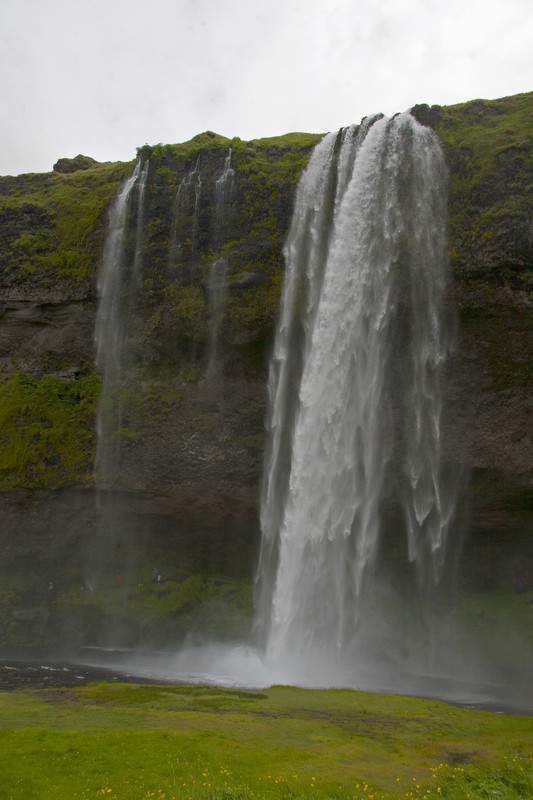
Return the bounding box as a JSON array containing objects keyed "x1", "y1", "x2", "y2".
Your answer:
[{"x1": 137, "y1": 127, "x2": 321, "y2": 362}]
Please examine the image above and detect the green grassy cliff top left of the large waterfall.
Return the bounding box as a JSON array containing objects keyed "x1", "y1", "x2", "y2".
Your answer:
[{"x1": 0, "y1": 131, "x2": 320, "y2": 290}]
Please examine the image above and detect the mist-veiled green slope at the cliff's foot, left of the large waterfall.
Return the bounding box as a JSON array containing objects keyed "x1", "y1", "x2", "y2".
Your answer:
[{"x1": 0, "y1": 564, "x2": 252, "y2": 657}]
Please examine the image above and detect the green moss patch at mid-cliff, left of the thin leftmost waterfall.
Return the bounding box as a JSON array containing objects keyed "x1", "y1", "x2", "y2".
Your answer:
[{"x1": 0, "y1": 373, "x2": 99, "y2": 490}]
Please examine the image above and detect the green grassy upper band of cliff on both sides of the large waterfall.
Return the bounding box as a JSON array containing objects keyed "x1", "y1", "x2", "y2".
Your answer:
[{"x1": 0, "y1": 92, "x2": 533, "y2": 294}]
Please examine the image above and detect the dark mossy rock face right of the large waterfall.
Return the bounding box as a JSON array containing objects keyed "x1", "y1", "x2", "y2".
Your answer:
[{"x1": 431, "y1": 94, "x2": 533, "y2": 586}]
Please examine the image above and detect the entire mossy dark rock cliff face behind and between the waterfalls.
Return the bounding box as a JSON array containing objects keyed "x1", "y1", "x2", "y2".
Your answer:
[{"x1": 0, "y1": 93, "x2": 533, "y2": 642}]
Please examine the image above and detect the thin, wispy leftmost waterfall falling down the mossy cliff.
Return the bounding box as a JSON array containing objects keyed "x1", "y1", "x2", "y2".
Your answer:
[{"x1": 94, "y1": 159, "x2": 149, "y2": 489}]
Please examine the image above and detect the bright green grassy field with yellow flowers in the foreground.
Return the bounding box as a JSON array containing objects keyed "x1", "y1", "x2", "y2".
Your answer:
[{"x1": 0, "y1": 683, "x2": 533, "y2": 800}]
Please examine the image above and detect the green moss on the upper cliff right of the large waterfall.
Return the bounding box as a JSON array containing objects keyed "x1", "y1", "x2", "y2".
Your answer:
[{"x1": 435, "y1": 92, "x2": 533, "y2": 288}]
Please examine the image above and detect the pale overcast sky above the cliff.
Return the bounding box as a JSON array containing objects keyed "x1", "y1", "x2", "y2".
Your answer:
[{"x1": 0, "y1": 0, "x2": 533, "y2": 175}]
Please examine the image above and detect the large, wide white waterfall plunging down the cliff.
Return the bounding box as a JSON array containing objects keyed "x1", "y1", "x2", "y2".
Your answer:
[{"x1": 257, "y1": 113, "x2": 453, "y2": 666}]
